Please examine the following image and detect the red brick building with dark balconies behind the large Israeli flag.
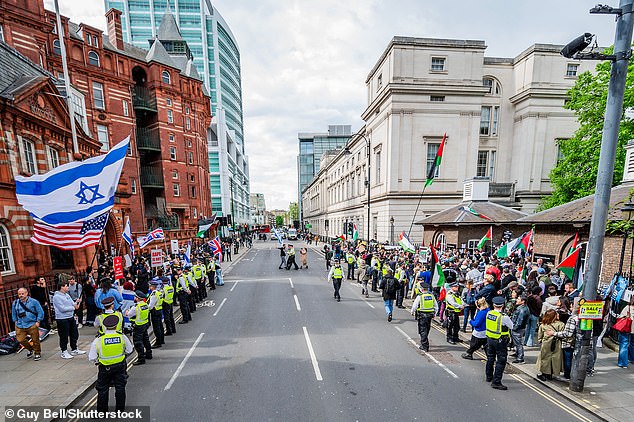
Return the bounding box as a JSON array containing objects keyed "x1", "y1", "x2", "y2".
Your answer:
[{"x1": 0, "y1": 0, "x2": 211, "y2": 286}]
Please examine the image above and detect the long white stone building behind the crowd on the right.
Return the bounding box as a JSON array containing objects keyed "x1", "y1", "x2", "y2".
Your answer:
[{"x1": 302, "y1": 37, "x2": 595, "y2": 242}]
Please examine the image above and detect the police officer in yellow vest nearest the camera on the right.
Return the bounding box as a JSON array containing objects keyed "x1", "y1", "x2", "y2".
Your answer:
[{"x1": 486, "y1": 296, "x2": 513, "y2": 390}]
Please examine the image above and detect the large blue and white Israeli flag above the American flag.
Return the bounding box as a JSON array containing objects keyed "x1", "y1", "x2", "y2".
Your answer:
[{"x1": 15, "y1": 136, "x2": 130, "y2": 226}]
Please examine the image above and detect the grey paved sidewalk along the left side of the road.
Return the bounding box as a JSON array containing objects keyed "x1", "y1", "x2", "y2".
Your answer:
[{"x1": 0, "y1": 242, "x2": 248, "y2": 420}]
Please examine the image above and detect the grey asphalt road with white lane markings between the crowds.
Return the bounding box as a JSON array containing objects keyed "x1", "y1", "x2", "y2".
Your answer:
[{"x1": 73, "y1": 241, "x2": 597, "y2": 422}]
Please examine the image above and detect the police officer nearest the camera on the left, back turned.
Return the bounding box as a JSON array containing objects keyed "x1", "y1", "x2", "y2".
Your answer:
[{"x1": 88, "y1": 314, "x2": 133, "y2": 412}]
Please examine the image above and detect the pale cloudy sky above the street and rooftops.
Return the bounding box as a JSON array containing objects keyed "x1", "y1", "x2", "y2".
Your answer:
[{"x1": 45, "y1": 0, "x2": 618, "y2": 209}]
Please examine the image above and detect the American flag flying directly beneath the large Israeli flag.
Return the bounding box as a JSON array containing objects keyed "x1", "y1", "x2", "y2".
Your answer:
[{"x1": 31, "y1": 212, "x2": 110, "y2": 250}]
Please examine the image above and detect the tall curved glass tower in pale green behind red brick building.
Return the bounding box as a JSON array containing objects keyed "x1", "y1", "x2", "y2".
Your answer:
[{"x1": 104, "y1": 0, "x2": 249, "y2": 223}]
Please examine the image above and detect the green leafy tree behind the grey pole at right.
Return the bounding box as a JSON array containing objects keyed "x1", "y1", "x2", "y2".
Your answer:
[{"x1": 540, "y1": 49, "x2": 634, "y2": 210}]
